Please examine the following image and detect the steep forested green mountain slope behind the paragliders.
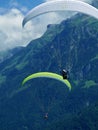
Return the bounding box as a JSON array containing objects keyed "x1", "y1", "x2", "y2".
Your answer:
[{"x1": 0, "y1": 14, "x2": 98, "y2": 130}]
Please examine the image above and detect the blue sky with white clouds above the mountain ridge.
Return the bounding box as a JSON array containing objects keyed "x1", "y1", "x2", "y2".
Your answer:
[{"x1": 0, "y1": 0, "x2": 92, "y2": 51}]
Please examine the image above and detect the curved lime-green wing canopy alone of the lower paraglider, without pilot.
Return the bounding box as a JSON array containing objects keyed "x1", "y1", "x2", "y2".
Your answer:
[{"x1": 22, "y1": 72, "x2": 72, "y2": 90}]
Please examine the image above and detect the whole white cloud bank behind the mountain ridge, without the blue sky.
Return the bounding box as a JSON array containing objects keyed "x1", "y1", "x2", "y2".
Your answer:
[{"x1": 0, "y1": 0, "x2": 95, "y2": 50}]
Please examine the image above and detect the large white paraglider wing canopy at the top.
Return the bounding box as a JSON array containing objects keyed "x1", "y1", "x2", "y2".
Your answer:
[{"x1": 22, "y1": 0, "x2": 98, "y2": 27}]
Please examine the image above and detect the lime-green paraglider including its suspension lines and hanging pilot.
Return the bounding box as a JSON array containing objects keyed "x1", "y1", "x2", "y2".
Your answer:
[{"x1": 22, "y1": 72, "x2": 72, "y2": 117}]
